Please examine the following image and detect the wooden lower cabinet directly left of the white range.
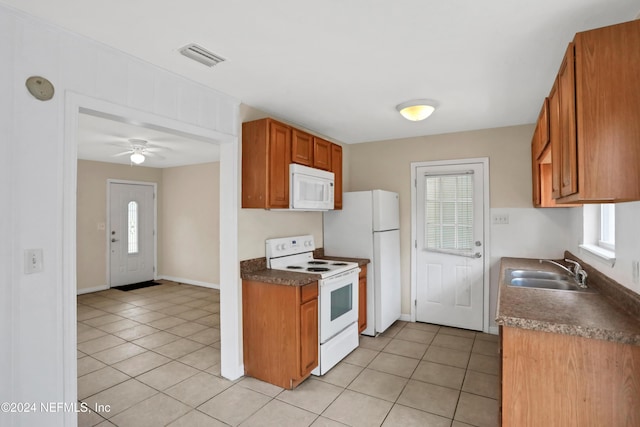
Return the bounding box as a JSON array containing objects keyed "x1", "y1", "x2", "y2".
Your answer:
[{"x1": 242, "y1": 280, "x2": 319, "y2": 389}]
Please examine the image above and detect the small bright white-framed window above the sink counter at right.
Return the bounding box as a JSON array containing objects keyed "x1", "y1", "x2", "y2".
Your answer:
[{"x1": 580, "y1": 203, "x2": 616, "y2": 266}]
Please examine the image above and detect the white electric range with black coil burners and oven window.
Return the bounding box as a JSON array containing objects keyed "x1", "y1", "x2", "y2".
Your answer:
[{"x1": 265, "y1": 235, "x2": 360, "y2": 375}]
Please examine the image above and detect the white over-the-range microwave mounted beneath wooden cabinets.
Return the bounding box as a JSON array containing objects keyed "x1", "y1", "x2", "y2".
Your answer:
[{"x1": 289, "y1": 163, "x2": 334, "y2": 211}]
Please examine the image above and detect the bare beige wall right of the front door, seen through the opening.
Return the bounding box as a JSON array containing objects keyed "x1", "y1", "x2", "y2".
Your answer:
[{"x1": 159, "y1": 162, "x2": 220, "y2": 285}]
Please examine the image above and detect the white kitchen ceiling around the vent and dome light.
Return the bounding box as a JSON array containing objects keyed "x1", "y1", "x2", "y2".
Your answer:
[{"x1": 5, "y1": 0, "x2": 640, "y2": 160}]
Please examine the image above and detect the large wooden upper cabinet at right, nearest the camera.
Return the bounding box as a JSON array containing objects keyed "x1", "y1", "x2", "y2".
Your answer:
[{"x1": 550, "y1": 20, "x2": 640, "y2": 204}]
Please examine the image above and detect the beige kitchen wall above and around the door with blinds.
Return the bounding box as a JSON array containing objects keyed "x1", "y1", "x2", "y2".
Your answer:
[{"x1": 348, "y1": 125, "x2": 534, "y2": 317}]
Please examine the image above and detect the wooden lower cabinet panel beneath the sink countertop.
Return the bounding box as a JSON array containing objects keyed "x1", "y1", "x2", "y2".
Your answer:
[{"x1": 501, "y1": 327, "x2": 640, "y2": 427}]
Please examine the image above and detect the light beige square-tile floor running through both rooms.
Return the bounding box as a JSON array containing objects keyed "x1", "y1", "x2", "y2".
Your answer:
[{"x1": 78, "y1": 281, "x2": 499, "y2": 427}]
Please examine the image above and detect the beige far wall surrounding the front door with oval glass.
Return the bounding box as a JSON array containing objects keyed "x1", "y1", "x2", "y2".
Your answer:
[{"x1": 76, "y1": 160, "x2": 162, "y2": 291}]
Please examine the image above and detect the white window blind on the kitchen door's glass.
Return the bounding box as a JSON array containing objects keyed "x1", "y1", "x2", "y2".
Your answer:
[{"x1": 424, "y1": 171, "x2": 473, "y2": 256}]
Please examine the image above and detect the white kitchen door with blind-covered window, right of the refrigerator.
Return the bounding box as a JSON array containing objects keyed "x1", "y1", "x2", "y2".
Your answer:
[{"x1": 416, "y1": 163, "x2": 484, "y2": 330}]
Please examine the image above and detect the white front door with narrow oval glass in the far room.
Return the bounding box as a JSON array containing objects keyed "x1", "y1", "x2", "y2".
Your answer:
[{"x1": 108, "y1": 182, "x2": 155, "y2": 287}]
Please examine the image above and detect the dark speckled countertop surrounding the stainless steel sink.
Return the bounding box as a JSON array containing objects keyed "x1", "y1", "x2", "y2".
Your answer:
[{"x1": 496, "y1": 257, "x2": 640, "y2": 345}]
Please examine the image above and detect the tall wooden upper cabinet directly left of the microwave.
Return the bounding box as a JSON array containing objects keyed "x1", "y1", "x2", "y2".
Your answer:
[{"x1": 242, "y1": 119, "x2": 291, "y2": 209}]
